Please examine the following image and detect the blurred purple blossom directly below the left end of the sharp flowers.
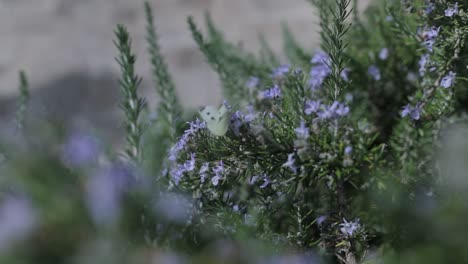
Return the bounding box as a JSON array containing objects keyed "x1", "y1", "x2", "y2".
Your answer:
[{"x1": 155, "y1": 193, "x2": 193, "y2": 223}]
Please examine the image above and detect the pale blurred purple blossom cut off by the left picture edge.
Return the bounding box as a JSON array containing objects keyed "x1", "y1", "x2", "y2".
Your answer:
[{"x1": 0, "y1": 197, "x2": 38, "y2": 250}]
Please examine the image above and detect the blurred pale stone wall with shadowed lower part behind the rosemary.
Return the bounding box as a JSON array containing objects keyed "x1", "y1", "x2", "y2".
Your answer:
[{"x1": 0, "y1": 0, "x2": 365, "y2": 141}]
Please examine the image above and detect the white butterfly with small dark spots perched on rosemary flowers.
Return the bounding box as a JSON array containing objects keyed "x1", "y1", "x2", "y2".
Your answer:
[{"x1": 199, "y1": 104, "x2": 229, "y2": 136}]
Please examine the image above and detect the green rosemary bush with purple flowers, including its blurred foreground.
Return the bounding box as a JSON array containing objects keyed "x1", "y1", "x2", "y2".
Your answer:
[{"x1": 0, "y1": 0, "x2": 468, "y2": 264}]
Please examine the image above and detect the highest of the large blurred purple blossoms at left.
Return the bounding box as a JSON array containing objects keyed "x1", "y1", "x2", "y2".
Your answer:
[{"x1": 63, "y1": 133, "x2": 101, "y2": 167}]
